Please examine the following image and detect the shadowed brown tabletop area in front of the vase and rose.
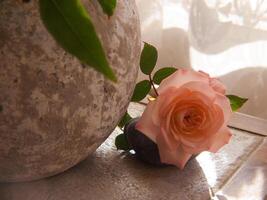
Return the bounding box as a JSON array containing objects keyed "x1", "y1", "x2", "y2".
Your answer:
[{"x1": 0, "y1": 144, "x2": 209, "y2": 200}]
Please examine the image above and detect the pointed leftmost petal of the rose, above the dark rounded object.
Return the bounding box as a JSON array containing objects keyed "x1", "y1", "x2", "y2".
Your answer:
[{"x1": 135, "y1": 101, "x2": 160, "y2": 142}]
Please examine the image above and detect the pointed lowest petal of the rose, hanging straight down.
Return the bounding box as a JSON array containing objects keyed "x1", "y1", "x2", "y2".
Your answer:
[{"x1": 157, "y1": 136, "x2": 192, "y2": 169}]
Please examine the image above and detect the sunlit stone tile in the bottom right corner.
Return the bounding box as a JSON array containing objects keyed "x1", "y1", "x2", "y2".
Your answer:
[{"x1": 217, "y1": 139, "x2": 267, "y2": 200}]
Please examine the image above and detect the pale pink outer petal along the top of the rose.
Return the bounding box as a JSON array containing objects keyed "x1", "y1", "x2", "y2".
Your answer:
[{"x1": 158, "y1": 69, "x2": 209, "y2": 94}]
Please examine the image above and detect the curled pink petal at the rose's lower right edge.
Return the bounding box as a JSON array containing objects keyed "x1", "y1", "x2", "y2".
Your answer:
[{"x1": 209, "y1": 126, "x2": 232, "y2": 153}]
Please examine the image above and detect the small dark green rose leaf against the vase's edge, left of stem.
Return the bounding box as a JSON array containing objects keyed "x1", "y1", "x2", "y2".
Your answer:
[{"x1": 131, "y1": 80, "x2": 151, "y2": 102}]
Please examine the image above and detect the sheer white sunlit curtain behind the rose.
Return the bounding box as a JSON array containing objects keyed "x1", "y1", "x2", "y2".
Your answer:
[{"x1": 136, "y1": 0, "x2": 267, "y2": 119}]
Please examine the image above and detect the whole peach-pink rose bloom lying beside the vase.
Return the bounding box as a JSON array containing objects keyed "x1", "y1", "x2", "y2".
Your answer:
[{"x1": 135, "y1": 69, "x2": 232, "y2": 169}]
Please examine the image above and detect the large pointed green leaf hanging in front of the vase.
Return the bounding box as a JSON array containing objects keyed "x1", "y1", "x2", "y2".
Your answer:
[{"x1": 39, "y1": 0, "x2": 116, "y2": 81}]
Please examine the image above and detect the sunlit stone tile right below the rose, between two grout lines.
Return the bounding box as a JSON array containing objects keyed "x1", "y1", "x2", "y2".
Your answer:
[{"x1": 197, "y1": 129, "x2": 263, "y2": 192}]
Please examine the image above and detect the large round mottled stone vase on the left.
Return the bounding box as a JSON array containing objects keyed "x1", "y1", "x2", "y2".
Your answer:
[{"x1": 0, "y1": 0, "x2": 141, "y2": 182}]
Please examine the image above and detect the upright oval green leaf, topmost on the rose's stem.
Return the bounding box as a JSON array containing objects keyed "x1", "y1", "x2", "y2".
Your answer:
[{"x1": 140, "y1": 43, "x2": 158, "y2": 75}]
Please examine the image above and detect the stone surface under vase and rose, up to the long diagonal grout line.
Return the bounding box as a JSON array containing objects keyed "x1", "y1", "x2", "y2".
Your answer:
[{"x1": 0, "y1": 104, "x2": 263, "y2": 200}]
